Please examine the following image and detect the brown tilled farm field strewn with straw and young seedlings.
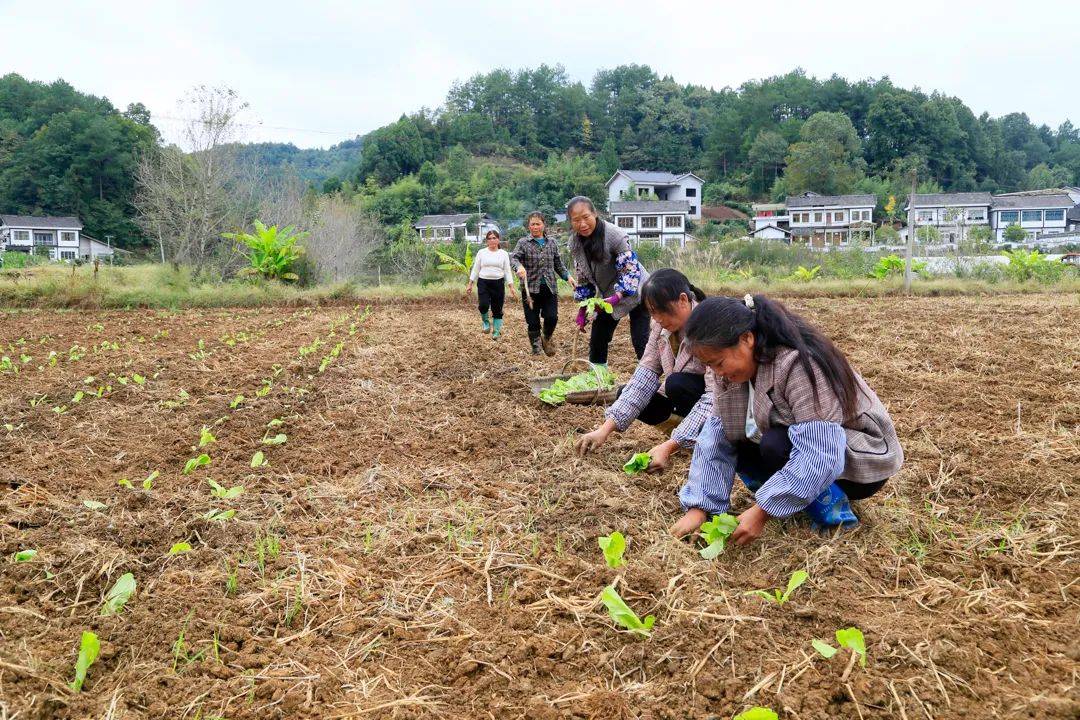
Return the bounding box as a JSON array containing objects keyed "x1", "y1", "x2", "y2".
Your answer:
[{"x1": 0, "y1": 294, "x2": 1080, "y2": 720}]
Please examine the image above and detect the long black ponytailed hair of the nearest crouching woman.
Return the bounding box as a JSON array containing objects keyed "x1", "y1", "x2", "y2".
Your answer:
[{"x1": 684, "y1": 295, "x2": 859, "y2": 420}]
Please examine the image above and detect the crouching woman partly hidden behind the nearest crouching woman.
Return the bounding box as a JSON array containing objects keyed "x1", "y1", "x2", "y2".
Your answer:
[{"x1": 577, "y1": 268, "x2": 713, "y2": 472}]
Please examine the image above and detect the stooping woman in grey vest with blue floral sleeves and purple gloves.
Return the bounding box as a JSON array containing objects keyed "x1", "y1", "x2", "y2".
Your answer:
[{"x1": 566, "y1": 195, "x2": 649, "y2": 368}]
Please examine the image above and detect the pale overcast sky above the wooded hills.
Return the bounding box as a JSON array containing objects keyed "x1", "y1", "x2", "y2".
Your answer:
[{"x1": 0, "y1": 0, "x2": 1080, "y2": 147}]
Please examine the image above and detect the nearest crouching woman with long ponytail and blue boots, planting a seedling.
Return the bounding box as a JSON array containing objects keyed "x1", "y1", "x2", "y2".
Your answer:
[{"x1": 672, "y1": 295, "x2": 904, "y2": 545}]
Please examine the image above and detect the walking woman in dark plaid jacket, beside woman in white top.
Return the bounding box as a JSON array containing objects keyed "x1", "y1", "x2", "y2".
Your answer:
[{"x1": 510, "y1": 210, "x2": 573, "y2": 356}]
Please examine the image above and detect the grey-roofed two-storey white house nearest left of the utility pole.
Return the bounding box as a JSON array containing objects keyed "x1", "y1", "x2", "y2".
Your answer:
[{"x1": 786, "y1": 192, "x2": 877, "y2": 247}]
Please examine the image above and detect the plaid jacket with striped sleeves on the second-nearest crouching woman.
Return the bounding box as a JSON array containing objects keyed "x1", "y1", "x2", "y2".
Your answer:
[{"x1": 604, "y1": 313, "x2": 713, "y2": 448}]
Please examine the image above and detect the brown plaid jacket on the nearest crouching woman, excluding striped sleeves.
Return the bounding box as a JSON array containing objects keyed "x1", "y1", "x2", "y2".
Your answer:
[{"x1": 711, "y1": 348, "x2": 904, "y2": 483}]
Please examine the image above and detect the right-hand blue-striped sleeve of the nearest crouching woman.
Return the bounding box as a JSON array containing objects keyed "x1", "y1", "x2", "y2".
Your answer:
[{"x1": 754, "y1": 420, "x2": 848, "y2": 517}]
